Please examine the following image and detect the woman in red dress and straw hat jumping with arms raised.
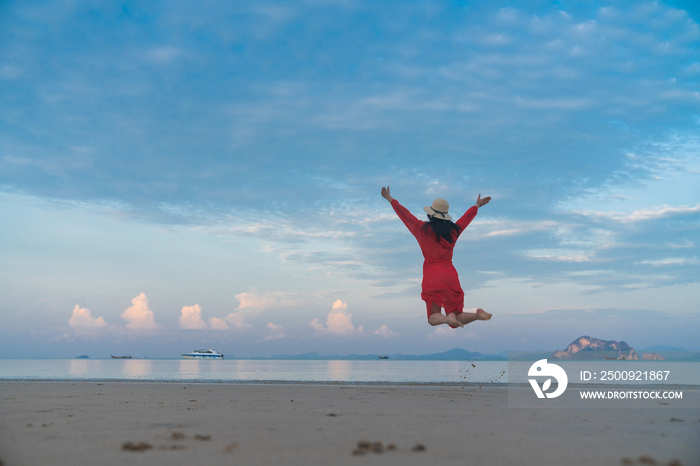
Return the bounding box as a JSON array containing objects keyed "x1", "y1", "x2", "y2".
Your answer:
[{"x1": 382, "y1": 186, "x2": 491, "y2": 328}]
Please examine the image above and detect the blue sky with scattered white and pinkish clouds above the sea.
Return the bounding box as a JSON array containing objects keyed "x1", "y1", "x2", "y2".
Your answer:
[{"x1": 0, "y1": 0, "x2": 700, "y2": 357}]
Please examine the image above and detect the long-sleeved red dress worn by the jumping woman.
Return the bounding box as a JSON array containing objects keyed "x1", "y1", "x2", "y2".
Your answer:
[{"x1": 391, "y1": 199, "x2": 479, "y2": 317}]
